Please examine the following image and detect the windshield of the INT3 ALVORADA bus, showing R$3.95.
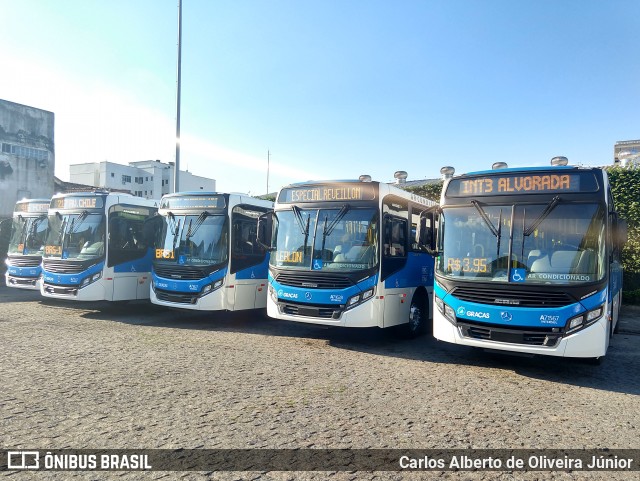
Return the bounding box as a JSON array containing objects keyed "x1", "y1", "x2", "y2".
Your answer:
[{"x1": 436, "y1": 200, "x2": 606, "y2": 284}]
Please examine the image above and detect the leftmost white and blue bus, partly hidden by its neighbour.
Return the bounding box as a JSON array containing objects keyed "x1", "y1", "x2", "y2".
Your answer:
[{"x1": 5, "y1": 199, "x2": 50, "y2": 290}]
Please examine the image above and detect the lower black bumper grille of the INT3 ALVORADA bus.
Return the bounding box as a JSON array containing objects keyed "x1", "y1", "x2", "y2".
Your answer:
[{"x1": 458, "y1": 321, "x2": 562, "y2": 347}]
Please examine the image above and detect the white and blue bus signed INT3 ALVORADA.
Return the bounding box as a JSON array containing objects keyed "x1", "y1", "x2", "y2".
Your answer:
[{"x1": 433, "y1": 157, "x2": 627, "y2": 362}]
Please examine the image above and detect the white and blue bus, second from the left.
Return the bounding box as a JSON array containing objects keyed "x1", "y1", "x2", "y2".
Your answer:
[{"x1": 40, "y1": 191, "x2": 157, "y2": 301}]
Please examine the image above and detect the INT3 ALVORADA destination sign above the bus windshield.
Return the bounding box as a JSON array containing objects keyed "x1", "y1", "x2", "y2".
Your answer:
[{"x1": 446, "y1": 173, "x2": 598, "y2": 197}]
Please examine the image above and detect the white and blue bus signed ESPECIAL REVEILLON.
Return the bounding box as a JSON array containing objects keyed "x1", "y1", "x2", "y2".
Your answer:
[{"x1": 258, "y1": 176, "x2": 436, "y2": 336}]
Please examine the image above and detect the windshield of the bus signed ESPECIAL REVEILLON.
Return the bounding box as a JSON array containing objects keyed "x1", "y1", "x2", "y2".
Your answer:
[{"x1": 270, "y1": 204, "x2": 378, "y2": 271}]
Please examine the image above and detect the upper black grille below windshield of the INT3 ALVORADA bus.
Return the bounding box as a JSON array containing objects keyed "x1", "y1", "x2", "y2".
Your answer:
[{"x1": 451, "y1": 287, "x2": 576, "y2": 307}]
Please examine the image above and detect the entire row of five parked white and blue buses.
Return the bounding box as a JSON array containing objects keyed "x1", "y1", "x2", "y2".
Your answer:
[{"x1": 6, "y1": 158, "x2": 626, "y2": 359}]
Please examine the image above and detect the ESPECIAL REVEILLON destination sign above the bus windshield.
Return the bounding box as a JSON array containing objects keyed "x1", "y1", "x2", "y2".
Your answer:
[{"x1": 278, "y1": 183, "x2": 376, "y2": 203}]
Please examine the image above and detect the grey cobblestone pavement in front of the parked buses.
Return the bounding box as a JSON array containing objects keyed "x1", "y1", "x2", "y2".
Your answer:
[{"x1": 0, "y1": 287, "x2": 640, "y2": 479}]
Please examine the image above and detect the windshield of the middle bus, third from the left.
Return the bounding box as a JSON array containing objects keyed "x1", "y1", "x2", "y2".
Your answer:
[{"x1": 157, "y1": 212, "x2": 229, "y2": 266}]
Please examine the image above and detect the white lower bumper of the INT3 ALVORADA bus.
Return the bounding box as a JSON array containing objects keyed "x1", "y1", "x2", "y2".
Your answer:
[{"x1": 433, "y1": 308, "x2": 609, "y2": 358}]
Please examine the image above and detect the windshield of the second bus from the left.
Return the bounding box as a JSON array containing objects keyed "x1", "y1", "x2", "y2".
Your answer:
[{"x1": 44, "y1": 210, "x2": 105, "y2": 261}]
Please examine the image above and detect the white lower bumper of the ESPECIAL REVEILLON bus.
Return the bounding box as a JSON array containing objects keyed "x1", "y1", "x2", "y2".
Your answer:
[{"x1": 267, "y1": 296, "x2": 383, "y2": 327}]
